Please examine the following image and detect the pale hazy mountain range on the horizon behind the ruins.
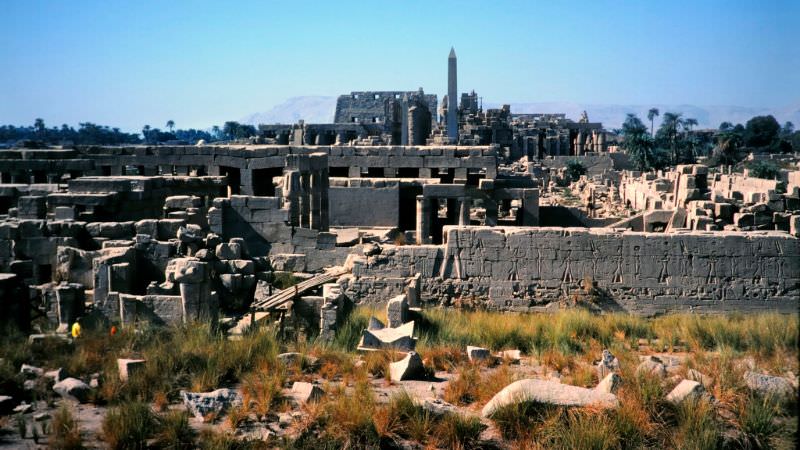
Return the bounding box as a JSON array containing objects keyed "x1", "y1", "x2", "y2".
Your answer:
[{"x1": 241, "y1": 96, "x2": 800, "y2": 129}]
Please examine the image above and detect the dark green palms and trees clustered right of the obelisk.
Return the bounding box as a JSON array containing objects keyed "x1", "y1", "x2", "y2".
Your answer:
[{"x1": 617, "y1": 108, "x2": 800, "y2": 170}]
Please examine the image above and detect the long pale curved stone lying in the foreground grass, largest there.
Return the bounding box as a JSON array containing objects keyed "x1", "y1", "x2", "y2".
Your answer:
[{"x1": 481, "y1": 379, "x2": 619, "y2": 417}]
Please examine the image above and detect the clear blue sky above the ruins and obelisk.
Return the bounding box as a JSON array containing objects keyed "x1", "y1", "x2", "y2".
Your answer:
[{"x1": 0, "y1": 0, "x2": 800, "y2": 130}]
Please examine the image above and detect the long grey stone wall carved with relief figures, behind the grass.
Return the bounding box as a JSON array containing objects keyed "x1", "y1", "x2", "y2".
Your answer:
[{"x1": 348, "y1": 227, "x2": 800, "y2": 315}]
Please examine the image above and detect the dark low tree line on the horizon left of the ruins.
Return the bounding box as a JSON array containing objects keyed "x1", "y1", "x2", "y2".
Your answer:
[{"x1": 0, "y1": 119, "x2": 258, "y2": 148}]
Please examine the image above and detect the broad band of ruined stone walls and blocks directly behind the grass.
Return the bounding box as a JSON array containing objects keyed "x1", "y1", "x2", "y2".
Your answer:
[{"x1": 0, "y1": 145, "x2": 800, "y2": 338}]
